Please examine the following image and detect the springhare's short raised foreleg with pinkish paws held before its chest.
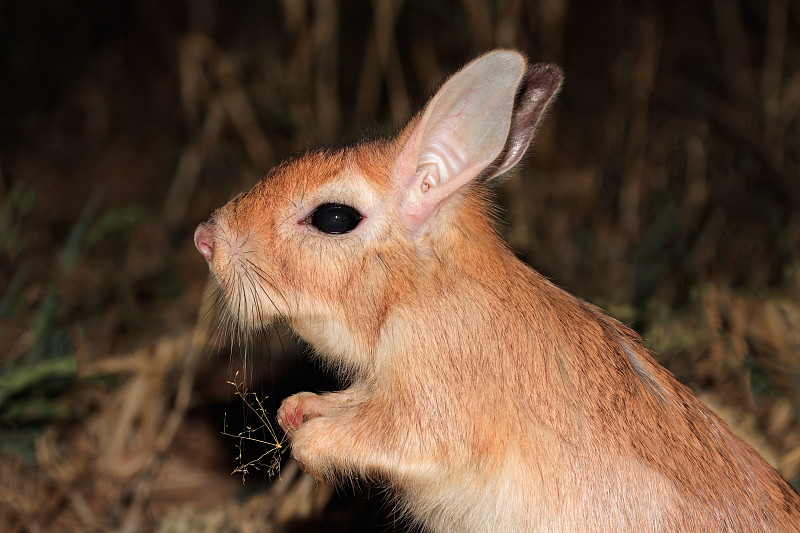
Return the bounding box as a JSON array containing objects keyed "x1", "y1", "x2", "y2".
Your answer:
[{"x1": 278, "y1": 387, "x2": 423, "y2": 482}]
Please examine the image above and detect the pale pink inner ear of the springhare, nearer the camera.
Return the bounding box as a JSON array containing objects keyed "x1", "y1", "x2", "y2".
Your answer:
[{"x1": 395, "y1": 50, "x2": 525, "y2": 228}]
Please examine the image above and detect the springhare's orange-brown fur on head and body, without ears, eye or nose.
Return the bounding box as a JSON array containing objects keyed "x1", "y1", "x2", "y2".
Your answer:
[{"x1": 198, "y1": 48, "x2": 800, "y2": 532}]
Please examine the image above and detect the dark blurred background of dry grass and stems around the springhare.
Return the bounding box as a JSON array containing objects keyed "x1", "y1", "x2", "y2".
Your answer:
[{"x1": 0, "y1": 0, "x2": 800, "y2": 532}]
